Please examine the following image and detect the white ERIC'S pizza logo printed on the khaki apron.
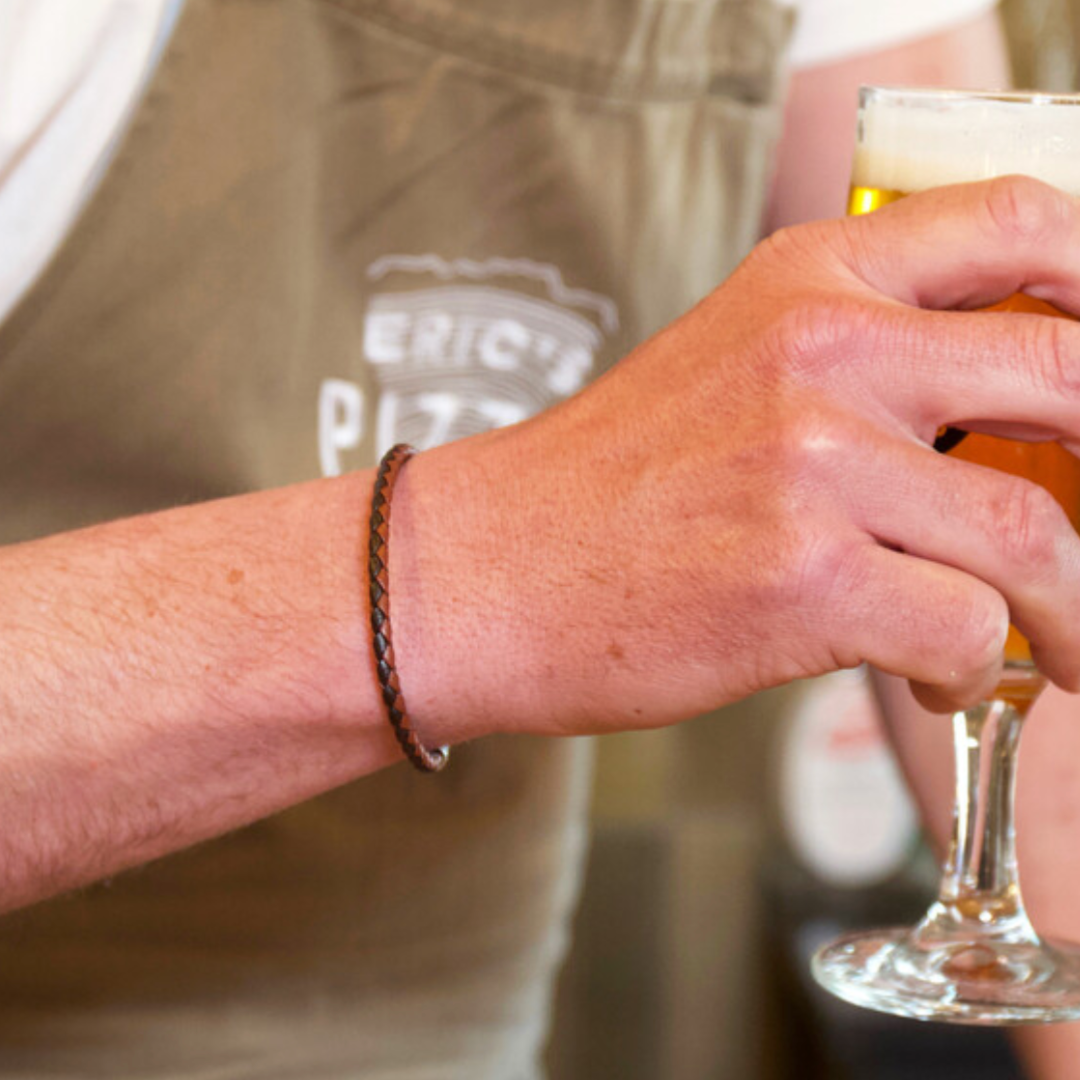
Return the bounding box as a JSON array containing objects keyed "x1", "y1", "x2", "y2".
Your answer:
[{"x1": 319, "y1": 255, "x2": 619, "y2": 475}]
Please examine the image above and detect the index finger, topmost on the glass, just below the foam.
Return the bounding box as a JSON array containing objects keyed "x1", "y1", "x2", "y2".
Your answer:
[{"x1": 847, "y1": 176, "x2": 1080, "y2": 314}]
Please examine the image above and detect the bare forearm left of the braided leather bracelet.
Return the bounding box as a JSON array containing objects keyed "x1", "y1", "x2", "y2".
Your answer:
[{"x1": 0, "y1": 474, "x2": 400, "y2": 908}]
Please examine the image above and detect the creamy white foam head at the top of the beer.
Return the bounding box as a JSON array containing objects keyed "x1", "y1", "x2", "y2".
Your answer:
[{"x1": 852, "y1": 92, "x2": 1080, "y2": 195}]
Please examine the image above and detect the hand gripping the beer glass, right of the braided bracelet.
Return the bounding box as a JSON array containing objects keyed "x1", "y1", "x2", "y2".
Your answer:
[{"x1": 392, "y1": 178, "x2": 1080, "y2": 741}]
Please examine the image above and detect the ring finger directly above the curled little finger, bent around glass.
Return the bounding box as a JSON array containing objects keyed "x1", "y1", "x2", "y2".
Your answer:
[{"x1": 843, "y1": 427, "x2": 1080, "y2": 689}]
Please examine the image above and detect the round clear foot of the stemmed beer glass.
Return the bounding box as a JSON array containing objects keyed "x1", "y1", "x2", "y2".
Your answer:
[{"x1": 813, "y1": 929, "x2": 1080, "y2": 1024}]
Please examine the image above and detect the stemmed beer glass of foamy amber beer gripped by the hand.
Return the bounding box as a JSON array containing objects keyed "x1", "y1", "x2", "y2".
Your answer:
[{"x1": 813, "y1": 87, "x2": 1080, "y2": 1024}]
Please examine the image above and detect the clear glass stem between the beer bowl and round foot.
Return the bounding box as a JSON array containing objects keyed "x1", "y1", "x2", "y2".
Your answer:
[{"x1": 923, "y1": 699, "x2": 1038, "y2": 942}]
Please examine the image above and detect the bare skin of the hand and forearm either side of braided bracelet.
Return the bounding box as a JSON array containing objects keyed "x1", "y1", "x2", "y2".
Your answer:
[{"x1": 6, "y1": 166, "x2": 1080, "y2": 907}]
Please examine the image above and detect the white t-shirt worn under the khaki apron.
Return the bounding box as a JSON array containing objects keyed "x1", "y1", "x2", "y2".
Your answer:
[{"x1": 0, "y1": 0, "x2": 996, "y2": 320}]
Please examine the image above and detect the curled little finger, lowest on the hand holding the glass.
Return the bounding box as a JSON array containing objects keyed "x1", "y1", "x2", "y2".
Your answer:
[{"x1": 822, "y1": 540, "x2": 1009, "y2": 712}]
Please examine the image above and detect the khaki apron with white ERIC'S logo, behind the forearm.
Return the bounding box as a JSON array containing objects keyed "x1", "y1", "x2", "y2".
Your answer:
[{"x1": 0, "y1": 0, "x2": 787, "y2": 1080}]
